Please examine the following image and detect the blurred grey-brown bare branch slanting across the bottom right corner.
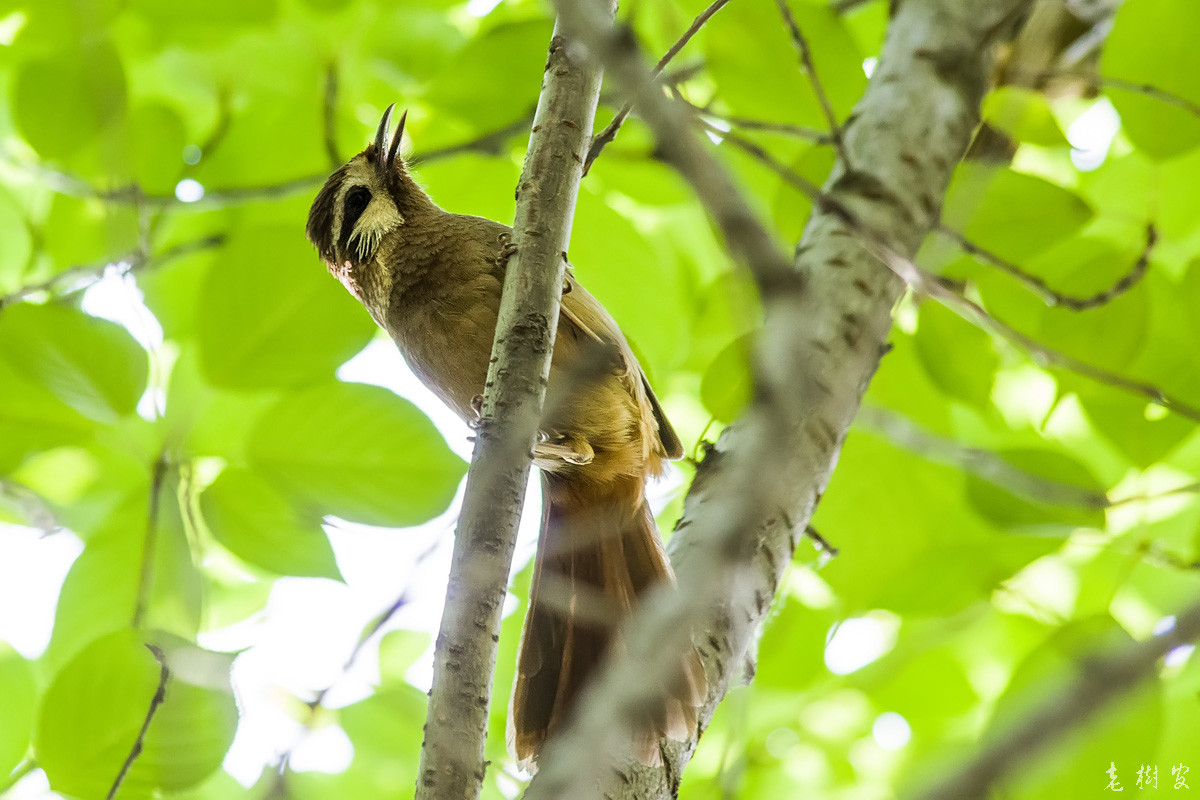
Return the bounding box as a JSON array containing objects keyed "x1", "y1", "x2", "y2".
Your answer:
[{"x1": 916, "y1": 603, "x2": 1200, "y2": 800}]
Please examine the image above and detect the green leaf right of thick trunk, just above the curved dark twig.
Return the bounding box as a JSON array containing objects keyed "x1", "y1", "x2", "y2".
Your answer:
[{"x1": 944, "y1": 162, "x2": 1092, "y2": 263}]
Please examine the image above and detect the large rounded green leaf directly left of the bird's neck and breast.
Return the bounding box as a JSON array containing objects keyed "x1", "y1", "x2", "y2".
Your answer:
[{"x1": 197, "y1": 223, "x2": 376, "y2": 389}]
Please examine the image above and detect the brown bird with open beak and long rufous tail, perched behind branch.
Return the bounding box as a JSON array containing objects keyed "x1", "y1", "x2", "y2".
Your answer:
[{"x1": 306, "y1": 103, "x2": 707, "y2": 771}]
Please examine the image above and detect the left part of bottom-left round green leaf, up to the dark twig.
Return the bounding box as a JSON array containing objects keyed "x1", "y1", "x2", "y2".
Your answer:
[{"x1": 34, "y1": 631, "x2": 161, "y2": 798}]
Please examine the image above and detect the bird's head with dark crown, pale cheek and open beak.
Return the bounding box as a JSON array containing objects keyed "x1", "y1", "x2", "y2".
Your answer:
[{"x1": 305, "y1": 103, "x2": 424, "y2": 278}]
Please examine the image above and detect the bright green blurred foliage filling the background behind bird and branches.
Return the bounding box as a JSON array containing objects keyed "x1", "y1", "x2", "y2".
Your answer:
[{"x1": 0, "y1": 0, "x2": 1200, "y2": 800}]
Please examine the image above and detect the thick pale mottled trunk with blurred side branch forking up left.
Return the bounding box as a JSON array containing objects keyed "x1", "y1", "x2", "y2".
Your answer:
[{"x1": 527, "y1": 0, "x2": 1026, "y2": 800}]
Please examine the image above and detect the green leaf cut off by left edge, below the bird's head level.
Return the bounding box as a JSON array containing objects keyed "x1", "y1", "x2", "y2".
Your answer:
[{"x1": 0, "y1": 303, "x2": 149, "y2": 422}]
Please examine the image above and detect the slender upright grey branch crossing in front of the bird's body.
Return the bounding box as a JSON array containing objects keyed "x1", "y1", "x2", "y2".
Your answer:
[{"x1": 416, "y1": 10, "x2": 614, "y2": 800}]
